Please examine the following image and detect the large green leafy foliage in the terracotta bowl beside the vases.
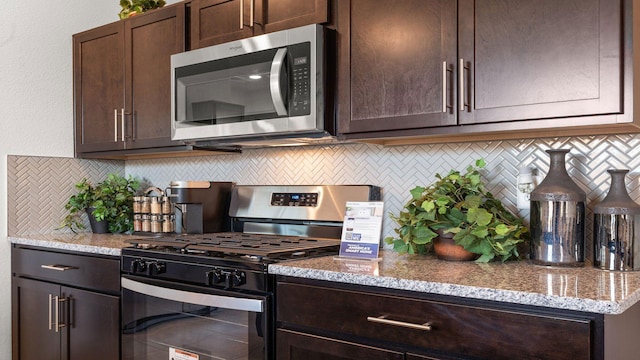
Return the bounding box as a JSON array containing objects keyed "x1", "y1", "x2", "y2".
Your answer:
[{"x1": 385, "y1": 159, "x2": 529, "y2": 262}]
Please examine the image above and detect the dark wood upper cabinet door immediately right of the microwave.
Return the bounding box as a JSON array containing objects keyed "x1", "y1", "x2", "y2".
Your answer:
[{"x1": 337, "y1": 0, "x2": 456, "y2": 133}]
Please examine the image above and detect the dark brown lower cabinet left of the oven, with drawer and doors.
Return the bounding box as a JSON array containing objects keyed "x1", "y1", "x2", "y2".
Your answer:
[{"x1": 12, "y1": 245, "x2": 120, "y2": 360}]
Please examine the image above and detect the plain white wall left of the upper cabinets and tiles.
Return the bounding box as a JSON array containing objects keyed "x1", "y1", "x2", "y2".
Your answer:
[{"x1": 0, "y1": 0, "x2": 177, "y2": 359}]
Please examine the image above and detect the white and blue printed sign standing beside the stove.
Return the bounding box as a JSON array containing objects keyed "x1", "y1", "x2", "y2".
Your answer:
[{"x1": 340, "y1": 201, "x2": 384, "y2": 259}]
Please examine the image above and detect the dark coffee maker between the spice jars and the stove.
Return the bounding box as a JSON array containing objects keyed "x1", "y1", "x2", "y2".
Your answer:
[{"x1": 166, "y1": 181, "x2": 233, "y2": 234}]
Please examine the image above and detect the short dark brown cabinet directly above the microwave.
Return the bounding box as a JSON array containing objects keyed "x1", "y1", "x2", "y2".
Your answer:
[{"x1": 190, "y1": 0, "x2": 329, "y2": 49}]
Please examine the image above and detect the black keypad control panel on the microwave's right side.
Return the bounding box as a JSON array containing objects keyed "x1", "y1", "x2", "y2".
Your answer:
[{"x1": 288, "y1": 42, "x2": 311, "y2": 116}]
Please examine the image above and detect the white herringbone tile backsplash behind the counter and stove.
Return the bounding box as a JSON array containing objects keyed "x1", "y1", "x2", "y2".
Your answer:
[{"x1": 8, "y1": 135, "x2": 640, "y2": 259}]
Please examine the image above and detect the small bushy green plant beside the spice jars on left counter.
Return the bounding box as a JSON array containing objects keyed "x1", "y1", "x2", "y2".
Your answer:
[{"x1": 60, "y1": 174, "x2": 140, "y2": 233}]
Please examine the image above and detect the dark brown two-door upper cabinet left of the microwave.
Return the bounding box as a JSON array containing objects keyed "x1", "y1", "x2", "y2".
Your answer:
[{"x1": 73, "y1": 4, "x2": 185, "y2": 156}]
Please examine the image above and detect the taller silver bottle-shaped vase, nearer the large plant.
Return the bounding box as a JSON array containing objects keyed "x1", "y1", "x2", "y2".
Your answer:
[{"x1": 530, "y1": 149, "x2": 587, "y2": 266}]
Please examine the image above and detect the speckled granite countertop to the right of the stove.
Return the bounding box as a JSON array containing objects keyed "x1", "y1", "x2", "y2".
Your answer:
[{"x1": 269, "y1": 250, "x2": 640, "y2": 314}]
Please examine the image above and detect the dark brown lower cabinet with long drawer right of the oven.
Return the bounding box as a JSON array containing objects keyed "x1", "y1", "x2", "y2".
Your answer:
[{"x1": 276, "y1": 278, "x2": 604, "y2": 360}]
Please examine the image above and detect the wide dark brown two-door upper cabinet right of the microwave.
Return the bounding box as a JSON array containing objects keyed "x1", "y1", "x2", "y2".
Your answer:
[{"x1": 336, "y1": 0, "x2": 638, "y2": 144}]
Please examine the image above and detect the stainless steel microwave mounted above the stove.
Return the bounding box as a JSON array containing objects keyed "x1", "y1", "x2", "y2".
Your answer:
[{"x1": 171, "y1": 25, "x2": 335, "y2": 144}]
